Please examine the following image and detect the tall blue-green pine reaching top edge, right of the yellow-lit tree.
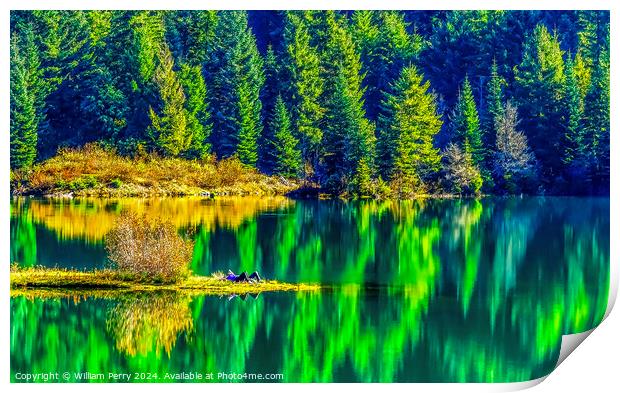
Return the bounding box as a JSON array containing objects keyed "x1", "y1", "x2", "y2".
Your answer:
[{"x1": 206, "y1": 11, "x2": 265, "y2": 166}]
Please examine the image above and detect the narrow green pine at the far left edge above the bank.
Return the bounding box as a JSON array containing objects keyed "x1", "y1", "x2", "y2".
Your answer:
[{"x1": 10, "y1": 30, "x2": 41, "y2": 169}]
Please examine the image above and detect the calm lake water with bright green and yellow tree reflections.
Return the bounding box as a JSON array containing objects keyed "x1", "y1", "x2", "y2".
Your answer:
[{"x1": 11, "y1": 197, "x2": 610, "y2": 382}]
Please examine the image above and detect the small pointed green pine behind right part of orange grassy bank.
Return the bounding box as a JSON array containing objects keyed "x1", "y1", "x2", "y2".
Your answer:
[{"x1": 269, "y1": 95, "x2": 301, "y2": 177}]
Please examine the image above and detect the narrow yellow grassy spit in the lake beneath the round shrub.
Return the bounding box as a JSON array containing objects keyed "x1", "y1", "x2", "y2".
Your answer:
[{"x1": 11, "y1": 267, "x2": 320, "y2": 295}]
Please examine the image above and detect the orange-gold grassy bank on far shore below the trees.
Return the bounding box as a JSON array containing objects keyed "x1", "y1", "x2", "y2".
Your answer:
[{"x1": 11, "y1": 144, "x2": 301, "y2": 197}]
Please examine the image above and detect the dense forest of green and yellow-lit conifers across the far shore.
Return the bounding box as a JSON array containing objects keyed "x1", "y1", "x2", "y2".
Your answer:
[{"x1": 10, "y1": 11, "x2": 609, "y2": 197}]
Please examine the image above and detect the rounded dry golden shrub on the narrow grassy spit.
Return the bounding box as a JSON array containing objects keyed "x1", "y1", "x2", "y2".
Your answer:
[{"x1": 105, "y1": 213, "x2": 194, "y2": 283}]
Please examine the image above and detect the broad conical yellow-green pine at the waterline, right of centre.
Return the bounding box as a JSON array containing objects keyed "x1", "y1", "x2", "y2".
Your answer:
[{"x1": 378, "y1": 66, "x2": 442, "y2": 196}]
